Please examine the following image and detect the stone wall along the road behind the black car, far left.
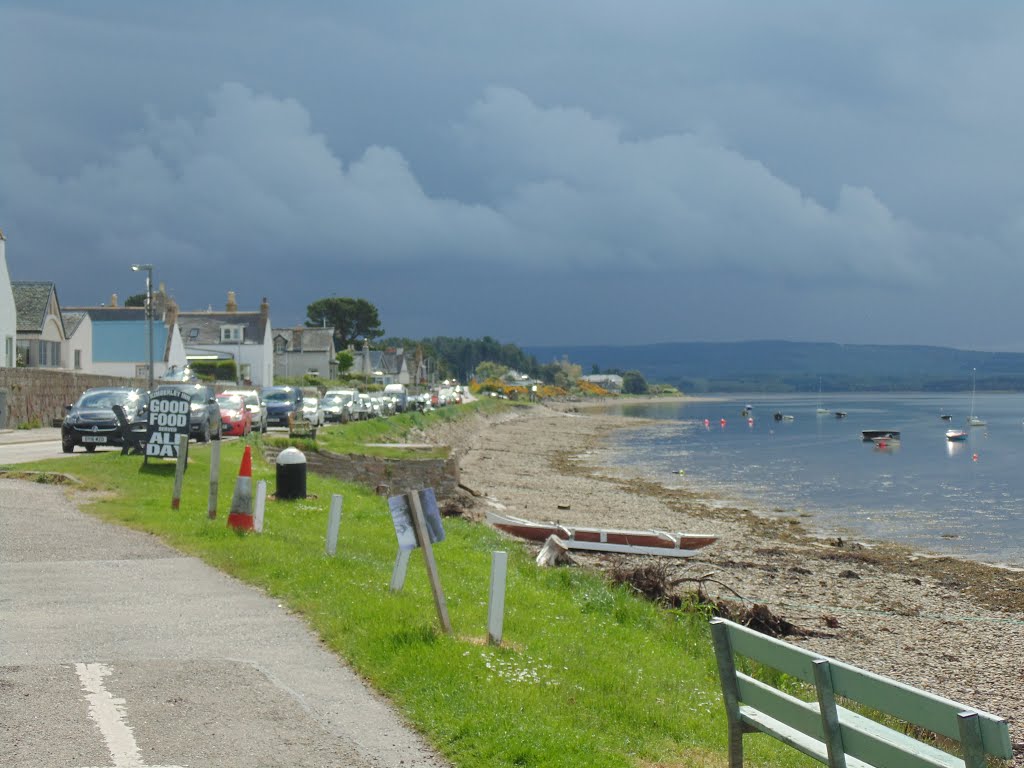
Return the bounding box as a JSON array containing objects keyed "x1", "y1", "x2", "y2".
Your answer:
[{"x1": 0, "y1": 368, "x2": 146, "y2": 429}]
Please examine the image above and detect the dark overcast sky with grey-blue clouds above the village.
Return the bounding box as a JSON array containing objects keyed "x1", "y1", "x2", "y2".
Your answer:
[{"x1": 0, "y1": 0, "x2": 1024, "y2": 350}]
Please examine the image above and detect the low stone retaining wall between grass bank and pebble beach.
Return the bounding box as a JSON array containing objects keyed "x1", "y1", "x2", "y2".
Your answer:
[{"x1": 266, "y1": 447, "x2": 459, "y2": 501}]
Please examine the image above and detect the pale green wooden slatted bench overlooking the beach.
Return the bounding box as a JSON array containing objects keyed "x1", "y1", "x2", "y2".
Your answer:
[{"x1": 711, "y1": 618, "x2": 1013, "y2": 768}]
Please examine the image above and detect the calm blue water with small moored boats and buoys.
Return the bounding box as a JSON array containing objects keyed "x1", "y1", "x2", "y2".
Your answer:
[{"x1": 601, "y1": 393, "x2": 1024, "y2": 565}]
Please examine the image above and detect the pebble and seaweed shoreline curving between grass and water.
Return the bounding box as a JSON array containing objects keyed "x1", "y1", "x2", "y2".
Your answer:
[{"x1": 450, "y1": 397, "x2": 1024, "y2": 766}]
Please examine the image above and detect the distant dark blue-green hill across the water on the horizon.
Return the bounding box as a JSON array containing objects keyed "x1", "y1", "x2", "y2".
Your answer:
[{"x1": 523, "y1": 341, "x2": 1024, "y2": 392}]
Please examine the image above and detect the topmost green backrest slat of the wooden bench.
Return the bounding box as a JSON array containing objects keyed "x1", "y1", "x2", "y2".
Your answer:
[{"x1": 715, "y1": 620, "x2": 1013, "y2": 759}]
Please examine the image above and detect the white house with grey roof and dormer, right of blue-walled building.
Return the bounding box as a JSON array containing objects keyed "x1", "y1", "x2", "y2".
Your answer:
[{"x1": 177, "y1": 291, "x2": 273, "y2": 387}]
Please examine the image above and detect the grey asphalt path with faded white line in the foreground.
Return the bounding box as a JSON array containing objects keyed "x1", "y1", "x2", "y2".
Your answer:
[{"x1": 0, "y1": 475, "x2": 447, "y2": 768}]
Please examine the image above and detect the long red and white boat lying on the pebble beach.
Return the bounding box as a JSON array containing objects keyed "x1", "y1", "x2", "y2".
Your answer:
[{"x1": 486, "y1": 511, "x2": 718, "y2": 557}]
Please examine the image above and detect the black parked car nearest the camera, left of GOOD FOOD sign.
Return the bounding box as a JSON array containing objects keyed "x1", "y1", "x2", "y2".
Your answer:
[{"x1": 60, "y1": 387, "x2": 150, "y2": 454}]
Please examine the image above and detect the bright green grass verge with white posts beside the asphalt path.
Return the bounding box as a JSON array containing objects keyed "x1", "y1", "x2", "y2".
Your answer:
[{"x1": 9, "y1": 438, "x2": 817, "y2": 768}]
